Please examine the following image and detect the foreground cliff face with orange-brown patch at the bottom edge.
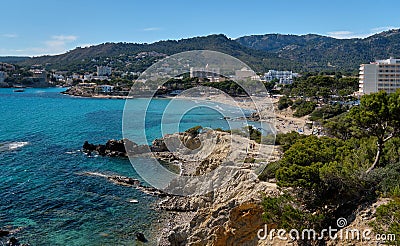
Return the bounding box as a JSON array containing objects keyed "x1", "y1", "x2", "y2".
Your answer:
[{"x1": 168, "y1": 170, "x2": 279, "y2": 246}]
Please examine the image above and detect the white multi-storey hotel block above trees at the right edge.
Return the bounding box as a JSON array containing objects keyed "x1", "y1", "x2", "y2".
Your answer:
[{"x1": 359, "y1": 58, "x2": 400, "y2": 94}]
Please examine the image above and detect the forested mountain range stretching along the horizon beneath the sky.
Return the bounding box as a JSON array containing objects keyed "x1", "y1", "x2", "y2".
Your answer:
[{"x1": 6, "y1": 29, "x2": 400, "y2": 73}]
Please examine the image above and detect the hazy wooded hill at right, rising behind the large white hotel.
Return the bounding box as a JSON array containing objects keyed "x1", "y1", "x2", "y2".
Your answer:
[{"x1": 236, "y1": 29, "x2": 400, "y2": 71}]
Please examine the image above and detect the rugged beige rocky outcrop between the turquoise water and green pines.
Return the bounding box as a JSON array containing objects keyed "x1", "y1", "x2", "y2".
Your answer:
[{"x1": 85, "y1": 131, "x2": 280, "y2": 246}]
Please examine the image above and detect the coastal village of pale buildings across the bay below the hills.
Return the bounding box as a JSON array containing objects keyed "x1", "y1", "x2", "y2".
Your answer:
[{"x1": 0, "y1": 60, "x2": 301, "y2": 97}]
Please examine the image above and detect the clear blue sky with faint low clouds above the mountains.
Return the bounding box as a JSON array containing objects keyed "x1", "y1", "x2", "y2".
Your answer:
[{"x1": 0, "y1": 0, "x2": 400, "y2": 56}]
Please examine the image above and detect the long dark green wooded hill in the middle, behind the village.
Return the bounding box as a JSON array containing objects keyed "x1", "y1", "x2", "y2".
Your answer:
[{"x1": 21, "y1": 34, "x2": 298, "y2": 71}]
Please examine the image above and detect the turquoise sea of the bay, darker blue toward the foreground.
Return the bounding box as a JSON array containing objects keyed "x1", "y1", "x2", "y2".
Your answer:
[{"x1": 0, "y1": 88, "x2": 250, "y2": 246}]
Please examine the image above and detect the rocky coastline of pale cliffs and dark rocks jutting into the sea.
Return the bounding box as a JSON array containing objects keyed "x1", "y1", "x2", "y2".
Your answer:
[{"x1": 82, "y1": 132, "x2": 280, "y2": 246}]
